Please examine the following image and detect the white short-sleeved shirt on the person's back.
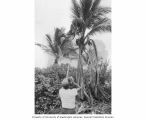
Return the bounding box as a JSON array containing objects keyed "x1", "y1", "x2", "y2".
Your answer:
[{"x1": 59, "y1": 88, "x2": 77, "y2": 109}]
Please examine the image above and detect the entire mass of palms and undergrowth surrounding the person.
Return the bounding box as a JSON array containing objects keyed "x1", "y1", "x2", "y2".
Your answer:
[{"x1": 35, "y1": 0, "x2": 111, "y2": 114}]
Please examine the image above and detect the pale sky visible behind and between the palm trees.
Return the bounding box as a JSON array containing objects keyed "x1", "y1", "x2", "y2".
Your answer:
[{"x1": 35, "y1": 0, "x2": 111, "y2": 68}]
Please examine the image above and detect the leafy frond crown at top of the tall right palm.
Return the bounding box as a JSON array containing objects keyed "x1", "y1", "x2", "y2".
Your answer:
[{"x1": 69, "y1": 0, "x2": 111, "y2": 41}]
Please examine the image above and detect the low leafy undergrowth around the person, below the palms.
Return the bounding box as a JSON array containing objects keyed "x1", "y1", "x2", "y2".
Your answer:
[{"x1": 35, "y1": 62, "x2": 111, "y2": 114}]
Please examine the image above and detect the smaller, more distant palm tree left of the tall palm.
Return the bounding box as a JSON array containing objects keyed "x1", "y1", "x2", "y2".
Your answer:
[{"x1": 36, "y1": 28, "x2": 76, "y2": 64}]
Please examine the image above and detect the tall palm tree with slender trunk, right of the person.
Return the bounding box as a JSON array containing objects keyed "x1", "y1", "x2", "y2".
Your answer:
[{"x1": 68, "y1": 0, "x2": 111, "y2": 98}]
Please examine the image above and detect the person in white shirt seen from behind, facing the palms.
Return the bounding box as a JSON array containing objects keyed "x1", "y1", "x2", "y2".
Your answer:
[{"x1": 59, "y1": 77, "x2": 80, "y2": 114}]
